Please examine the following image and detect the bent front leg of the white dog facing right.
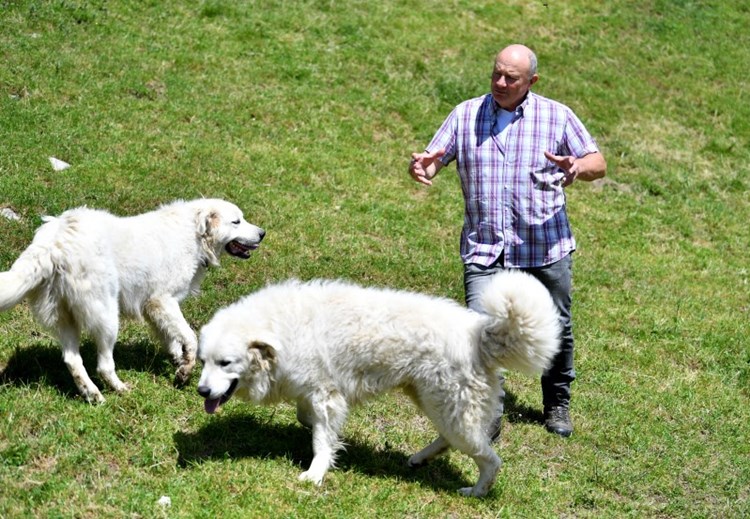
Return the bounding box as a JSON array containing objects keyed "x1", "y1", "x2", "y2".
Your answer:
[{"x1": 145, "y1": 297, "x2": 198, "y2": 385}]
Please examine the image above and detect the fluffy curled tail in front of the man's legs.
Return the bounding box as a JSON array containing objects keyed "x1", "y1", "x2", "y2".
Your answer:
[{"x1": 479, "y1": 270, "x2": 561, "y2": 375}]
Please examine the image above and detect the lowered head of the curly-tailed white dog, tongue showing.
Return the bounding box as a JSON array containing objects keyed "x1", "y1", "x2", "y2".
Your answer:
[{"x1": 198, "y1": 315, "x2": 276, "y2": 414}]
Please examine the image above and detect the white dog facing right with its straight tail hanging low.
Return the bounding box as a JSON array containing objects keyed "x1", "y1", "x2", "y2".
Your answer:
[{"x1": 0, "y1": 199, "x2": 265, "y2": 403}]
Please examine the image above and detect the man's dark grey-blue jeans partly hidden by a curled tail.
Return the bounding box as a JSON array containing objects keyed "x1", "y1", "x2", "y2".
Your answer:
[{"x1": 464, "y1": 254, "x2": 576, "y2": 412}]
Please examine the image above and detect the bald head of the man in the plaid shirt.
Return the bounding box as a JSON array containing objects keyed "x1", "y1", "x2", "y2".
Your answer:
[{"x1": 491, "y1": 44, "x2": 539, "y2": 112}]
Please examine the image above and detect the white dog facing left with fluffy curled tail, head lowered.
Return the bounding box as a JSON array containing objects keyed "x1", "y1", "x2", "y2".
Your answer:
[{"x1": 198, "y1": 272, "x2": 560, "y2": 496}]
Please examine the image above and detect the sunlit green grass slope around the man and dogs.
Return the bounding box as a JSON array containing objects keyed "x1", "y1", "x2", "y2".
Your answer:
[{"x1": 0, "y1": 0, "x2": 750, "y2": 518}]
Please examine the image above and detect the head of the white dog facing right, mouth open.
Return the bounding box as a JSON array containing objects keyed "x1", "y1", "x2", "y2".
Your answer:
[{"x1": 196, "y1": 198, "x2": 266, "y2": 265}]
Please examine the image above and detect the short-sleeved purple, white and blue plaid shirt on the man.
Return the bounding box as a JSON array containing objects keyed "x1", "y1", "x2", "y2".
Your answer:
[{"x1": 427, "y1": 92, "x2": 599, "y2": 268}]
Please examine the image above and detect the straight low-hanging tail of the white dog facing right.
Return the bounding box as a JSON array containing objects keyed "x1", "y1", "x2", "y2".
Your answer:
[{"x1": 0, "y1": 217, "x2": 58, "y2": 311}]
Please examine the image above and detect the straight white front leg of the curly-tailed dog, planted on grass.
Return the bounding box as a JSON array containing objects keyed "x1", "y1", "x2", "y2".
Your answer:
[{"x1": 299, "y1": 390, "x2": 349, "y2": 485}]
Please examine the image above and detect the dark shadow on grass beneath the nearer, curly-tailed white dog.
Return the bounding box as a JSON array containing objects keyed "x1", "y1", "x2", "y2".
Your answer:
[{"x1": 174, "y1": 415, "x2": 474, "y2": 493}]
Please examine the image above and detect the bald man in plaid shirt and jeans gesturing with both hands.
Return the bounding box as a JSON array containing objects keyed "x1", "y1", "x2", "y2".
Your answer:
[{"x1": 409, "y1": 44, "x2": 607, "y2": 439}]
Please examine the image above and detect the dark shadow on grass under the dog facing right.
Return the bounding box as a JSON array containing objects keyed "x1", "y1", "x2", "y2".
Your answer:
[{"x1": 0, "y1": 340, "x2": 174, "y2": 398}]
